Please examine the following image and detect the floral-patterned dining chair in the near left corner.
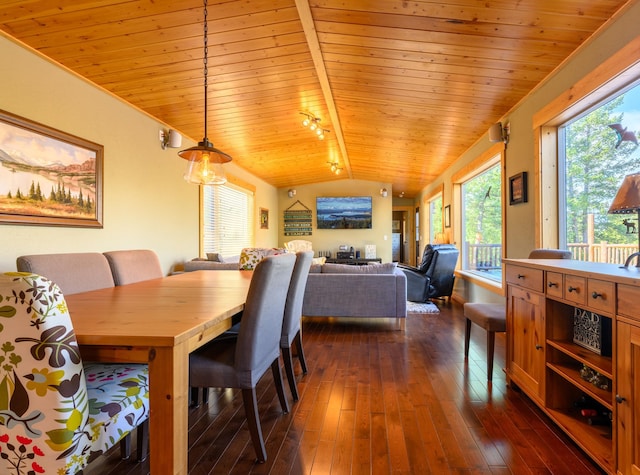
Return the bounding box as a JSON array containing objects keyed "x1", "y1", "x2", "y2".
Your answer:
[{"x1": 0, "y1": 272, "x2": 149, "y2": 475}]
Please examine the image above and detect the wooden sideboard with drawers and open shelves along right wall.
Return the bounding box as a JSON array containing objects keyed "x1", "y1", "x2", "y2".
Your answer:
[{"x1": 504, "y1": 259, "x2": 640, "y2": 475}]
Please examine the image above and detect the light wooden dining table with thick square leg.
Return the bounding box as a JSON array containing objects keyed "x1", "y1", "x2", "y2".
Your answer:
[{"x1": 65, "y1": 270, "x2": 253, "y2": 475}]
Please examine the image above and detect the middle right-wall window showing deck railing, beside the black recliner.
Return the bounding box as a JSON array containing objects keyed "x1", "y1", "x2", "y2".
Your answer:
[{"x1": 460, "y1": 160, "x2": 502, "y2": 282}]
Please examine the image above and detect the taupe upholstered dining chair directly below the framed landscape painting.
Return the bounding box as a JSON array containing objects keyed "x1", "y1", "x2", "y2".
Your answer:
[{"x1": 16, "y1": 252, "x2": 149, "y2": 462}]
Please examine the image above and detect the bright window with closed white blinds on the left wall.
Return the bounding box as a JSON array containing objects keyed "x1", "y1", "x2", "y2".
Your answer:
[{"x1": 201, "y1": 182, "x2": 254, "y2": 257}]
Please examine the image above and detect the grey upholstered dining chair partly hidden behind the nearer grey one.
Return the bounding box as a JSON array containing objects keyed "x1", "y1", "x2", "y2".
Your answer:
[{"x1": 280, "y1": 251, "x2": 313, "y2": 401}]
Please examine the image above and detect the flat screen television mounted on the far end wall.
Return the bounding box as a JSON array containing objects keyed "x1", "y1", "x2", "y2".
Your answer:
[{"x1": 316, "y1": 196, "x2": 371, "y2": 229}]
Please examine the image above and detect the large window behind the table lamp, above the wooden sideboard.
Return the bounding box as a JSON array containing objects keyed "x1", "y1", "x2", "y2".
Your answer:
[{"x1": 558, "y1": 81, "x2": 640, "y2": 264}]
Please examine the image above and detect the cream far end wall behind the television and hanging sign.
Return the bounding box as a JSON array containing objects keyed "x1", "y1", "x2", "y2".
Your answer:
[{"x1": 278, "y1": 180, "x2": 393, "y2": 262}]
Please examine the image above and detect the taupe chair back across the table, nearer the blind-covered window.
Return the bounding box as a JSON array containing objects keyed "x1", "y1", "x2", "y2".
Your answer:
[{"x1": 104, "y1": 249, "x2": 163, "y2": 285}]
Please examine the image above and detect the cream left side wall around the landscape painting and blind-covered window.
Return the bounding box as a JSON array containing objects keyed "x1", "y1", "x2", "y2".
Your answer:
[{"x1": 0, "y1": 36, "x2": 278, "y2": 273}]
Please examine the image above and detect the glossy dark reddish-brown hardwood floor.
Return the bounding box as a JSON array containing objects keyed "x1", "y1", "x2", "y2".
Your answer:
[{"x1": 85, "y1": 301, "x2": 602, "y2": 475}]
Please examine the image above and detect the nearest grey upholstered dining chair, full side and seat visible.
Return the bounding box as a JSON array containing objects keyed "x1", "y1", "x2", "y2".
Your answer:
[{"x1": 189, "y1": 254, "x2": 296, "y2": 462}]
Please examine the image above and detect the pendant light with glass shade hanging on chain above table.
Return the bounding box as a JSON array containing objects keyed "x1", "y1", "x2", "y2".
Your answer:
[{"x1": 178, "y1": 0, "x2": 231, "y2": 185}]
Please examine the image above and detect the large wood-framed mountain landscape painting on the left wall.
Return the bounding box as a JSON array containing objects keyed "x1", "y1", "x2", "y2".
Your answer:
[{"x1": 0, "y1": 111, "x2": 104, "y2": 228}]
